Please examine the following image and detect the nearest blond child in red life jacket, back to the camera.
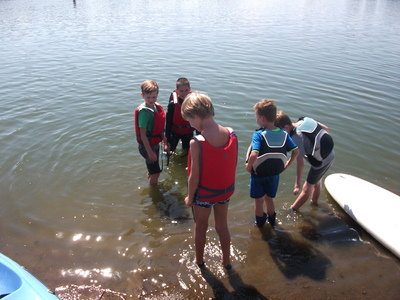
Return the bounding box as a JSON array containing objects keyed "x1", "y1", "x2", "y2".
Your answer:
[{"x1": 182, "y1": 93, "x2": 238, "y2": 269}]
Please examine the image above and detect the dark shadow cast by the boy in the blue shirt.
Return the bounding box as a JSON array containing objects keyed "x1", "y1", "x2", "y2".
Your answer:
[{"x1": 260, "y1": 226, "x2": 331, "y2": 281}]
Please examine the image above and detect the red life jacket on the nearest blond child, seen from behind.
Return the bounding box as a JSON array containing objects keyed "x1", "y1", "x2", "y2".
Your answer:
[{"x1": 188, "y1": 127, "x2": 238, "y2": 202}]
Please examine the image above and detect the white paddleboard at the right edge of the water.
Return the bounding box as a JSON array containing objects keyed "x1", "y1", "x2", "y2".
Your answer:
[{"x1": 325, "y1": 173, "x2": 400, "y2": 258}]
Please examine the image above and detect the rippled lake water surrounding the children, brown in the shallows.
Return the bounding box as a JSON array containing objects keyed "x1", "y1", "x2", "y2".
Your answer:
[{"x1": 0, "y1": 0, "x2": 400, "y2": 299}]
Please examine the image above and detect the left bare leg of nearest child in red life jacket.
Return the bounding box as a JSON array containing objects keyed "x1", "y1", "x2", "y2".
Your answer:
[{"x1": 193, "y1": 205, "x2": 211, "y2": 264}]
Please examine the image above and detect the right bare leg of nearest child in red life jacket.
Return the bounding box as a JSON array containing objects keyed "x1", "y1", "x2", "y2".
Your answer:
[{"x1": 213, "y1": 203, "x2": 231, "y2": 266}]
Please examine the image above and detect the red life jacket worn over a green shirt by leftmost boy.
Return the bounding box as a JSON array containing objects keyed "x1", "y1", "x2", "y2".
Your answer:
[{"x1": 135, "y1": 103, "x2": 165, "y2": 146}]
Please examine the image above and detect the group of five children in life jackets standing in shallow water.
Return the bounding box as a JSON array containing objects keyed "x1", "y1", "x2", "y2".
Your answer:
[{"x1": 135, "y1": 78, "x2": 334, "y2": 269}]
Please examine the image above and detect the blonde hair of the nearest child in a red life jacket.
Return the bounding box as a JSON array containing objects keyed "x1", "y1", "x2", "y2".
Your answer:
[{"x1": 181, "y1": 93, "x2": 215, "y2": 120}]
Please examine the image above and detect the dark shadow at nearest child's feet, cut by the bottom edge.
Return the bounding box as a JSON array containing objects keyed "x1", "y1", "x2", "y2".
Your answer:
[{"x1": 201, "y1": 268, "x2": 268, "y2": 300}]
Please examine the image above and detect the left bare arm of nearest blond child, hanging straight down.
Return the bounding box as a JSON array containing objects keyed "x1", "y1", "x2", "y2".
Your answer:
[{"x1": 185, "y1": 140, "x2": 200, "y2": 206}]
